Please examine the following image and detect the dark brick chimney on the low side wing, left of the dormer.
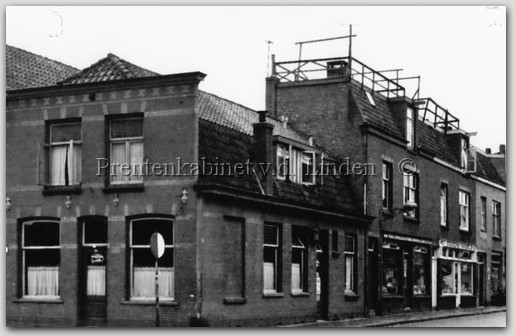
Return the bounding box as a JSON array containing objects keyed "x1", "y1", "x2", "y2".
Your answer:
[{"x1": 252, "y1": 111, "x2": 274, "y2": 195}]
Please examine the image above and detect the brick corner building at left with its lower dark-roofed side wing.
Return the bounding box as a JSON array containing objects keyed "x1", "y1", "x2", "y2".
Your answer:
[{"x1": 6, "y1": 46, "x2": 372, "y2": 327}]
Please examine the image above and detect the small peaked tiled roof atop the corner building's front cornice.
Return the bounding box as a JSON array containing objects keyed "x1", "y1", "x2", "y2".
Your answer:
[{"x1": 61, "y1": 54, "x2": 159, "y2": 85}]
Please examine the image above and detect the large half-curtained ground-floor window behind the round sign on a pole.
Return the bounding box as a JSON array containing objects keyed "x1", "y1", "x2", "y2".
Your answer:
[{"x1": 129, "y1": 217, "x2": 174, "y2": 300}]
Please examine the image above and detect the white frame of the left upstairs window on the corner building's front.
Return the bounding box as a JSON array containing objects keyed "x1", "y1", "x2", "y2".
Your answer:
[{"x1": 48, "y1": 121, "x2": 82, "y2": 186}]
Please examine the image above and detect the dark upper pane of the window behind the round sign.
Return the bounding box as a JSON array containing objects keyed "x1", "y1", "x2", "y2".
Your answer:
[{"x1": 132, "y1": 219, "x2": 173, "y2": 245}]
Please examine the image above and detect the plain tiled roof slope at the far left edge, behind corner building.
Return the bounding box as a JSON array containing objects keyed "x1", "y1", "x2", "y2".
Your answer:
[{"x1": 5, "y1": 45, "x2": 79, "y2": 90}]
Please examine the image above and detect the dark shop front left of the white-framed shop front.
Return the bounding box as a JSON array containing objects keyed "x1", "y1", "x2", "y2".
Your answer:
[{"x1": 380, "y1": 233, "x2": 432, "y2": 314}]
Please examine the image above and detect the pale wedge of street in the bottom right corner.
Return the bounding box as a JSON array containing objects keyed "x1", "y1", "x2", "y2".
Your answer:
[{"x1": 393, "y1": 311, "x2": 506, "y2": 328}]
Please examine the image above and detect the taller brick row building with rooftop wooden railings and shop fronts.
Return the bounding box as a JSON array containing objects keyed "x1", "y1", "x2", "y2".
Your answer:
[{"x1": 266, "y1": 53, "x2": 505, "y2": 313}]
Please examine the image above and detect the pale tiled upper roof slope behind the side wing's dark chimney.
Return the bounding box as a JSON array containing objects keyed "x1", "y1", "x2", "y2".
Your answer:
[{"x1": 198, "y1": 91, "x2": 308, "y2": 144}]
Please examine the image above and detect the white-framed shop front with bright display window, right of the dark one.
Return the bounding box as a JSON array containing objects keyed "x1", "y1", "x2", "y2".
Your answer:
[{"x1": 434, "y1": 239, "x2": 481, "y2": 309}]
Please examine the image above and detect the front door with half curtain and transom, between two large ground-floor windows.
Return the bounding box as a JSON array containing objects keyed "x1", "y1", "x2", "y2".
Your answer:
[{"x1": 79, "y1": 218, "x2": 107, "y2": 326}]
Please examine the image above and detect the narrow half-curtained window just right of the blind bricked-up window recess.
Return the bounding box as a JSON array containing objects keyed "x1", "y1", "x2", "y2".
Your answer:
[{"x1": 263, "y1": 224, "x2": 281, "y2": 294}]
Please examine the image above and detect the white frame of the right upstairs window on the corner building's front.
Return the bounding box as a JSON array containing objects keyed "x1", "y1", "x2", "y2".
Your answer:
[{"x1": 109, "y1": 117, "x2": 145, "y2": 185}]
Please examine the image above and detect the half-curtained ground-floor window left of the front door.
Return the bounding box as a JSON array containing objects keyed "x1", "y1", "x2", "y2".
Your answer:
[{"x1": 21, "y1": 220, "x2": 61, "y2": 298}]
